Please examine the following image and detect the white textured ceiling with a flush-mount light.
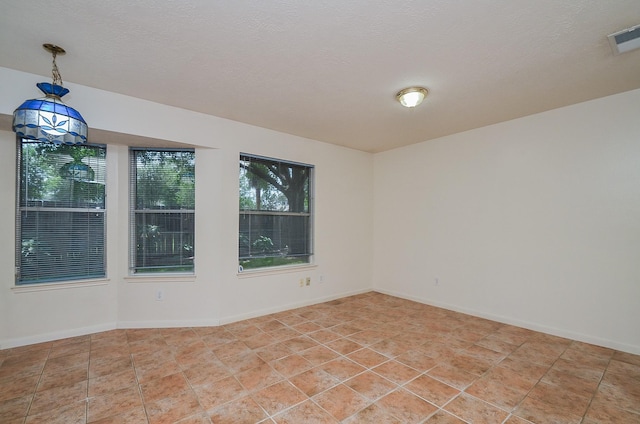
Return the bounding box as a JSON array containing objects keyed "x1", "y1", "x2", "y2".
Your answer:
[{"x1": 0, "y1": 0, "x2": 640, "y2": 152}]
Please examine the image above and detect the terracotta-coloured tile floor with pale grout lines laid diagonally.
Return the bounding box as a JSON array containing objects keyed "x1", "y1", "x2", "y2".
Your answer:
[{"x1": 0, "y1": 292, "x2": 640, "y2": 424}]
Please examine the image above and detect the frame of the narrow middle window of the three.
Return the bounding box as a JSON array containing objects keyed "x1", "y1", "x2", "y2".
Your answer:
[{"x1": 128, "y1": 147, "x2": 196, "y2": 278}]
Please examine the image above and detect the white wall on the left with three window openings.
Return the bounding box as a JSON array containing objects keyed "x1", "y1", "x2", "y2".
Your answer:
[{"x1": 0, "y1": 68, "x2": 373, "y2": 348}]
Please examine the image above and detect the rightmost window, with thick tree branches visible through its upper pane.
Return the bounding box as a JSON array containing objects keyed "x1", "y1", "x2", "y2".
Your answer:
[{"x1": 238, "y1": 154, "x2": 313, "y2": 270}]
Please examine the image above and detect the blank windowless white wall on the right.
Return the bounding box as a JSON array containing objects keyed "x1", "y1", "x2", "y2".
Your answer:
[{"x1": 373, "y1": 90, "x2": 640, "y2": 353}]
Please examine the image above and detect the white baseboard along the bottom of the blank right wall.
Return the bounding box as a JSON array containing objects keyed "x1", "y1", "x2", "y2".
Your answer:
[{"x1": 373, "y1": 288, "x2": 640, "y2": 355}]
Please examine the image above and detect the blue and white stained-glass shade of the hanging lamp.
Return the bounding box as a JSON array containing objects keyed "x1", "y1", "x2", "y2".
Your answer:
[{"x1": 13, "y1": 82, "x2": 87, "y2": 144}]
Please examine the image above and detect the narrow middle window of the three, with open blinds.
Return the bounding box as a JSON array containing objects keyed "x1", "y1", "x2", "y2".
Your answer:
[{"x1": 129, "y1": 149, "x2": 195, "y2": 273}]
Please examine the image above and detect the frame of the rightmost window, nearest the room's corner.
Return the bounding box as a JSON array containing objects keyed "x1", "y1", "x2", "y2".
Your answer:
[{"x1": 238, "y1": 152, "x2": 315, "y2": 273}]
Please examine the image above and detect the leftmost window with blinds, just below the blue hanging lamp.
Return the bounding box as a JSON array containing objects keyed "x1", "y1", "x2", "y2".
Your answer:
[{"x1": 16, "y1": 139, "x2": 106, "y2": 285}]
